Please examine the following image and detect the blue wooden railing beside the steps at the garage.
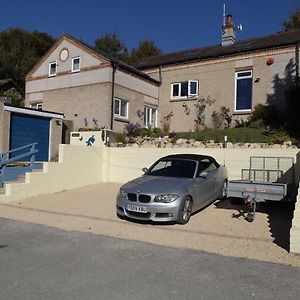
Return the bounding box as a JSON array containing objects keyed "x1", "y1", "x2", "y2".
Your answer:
[{"x1": 0, "y1": 143, "x2": 38, "y2": 187}]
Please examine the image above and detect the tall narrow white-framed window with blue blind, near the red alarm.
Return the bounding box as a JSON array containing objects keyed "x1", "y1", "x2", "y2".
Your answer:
[{"x1": 235, "y1": 70, "x2": 252, "y2": 111}]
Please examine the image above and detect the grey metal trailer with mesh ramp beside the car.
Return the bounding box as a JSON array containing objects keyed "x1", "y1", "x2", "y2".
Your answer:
[{"x1": 225, "y1": 156, "x2": 297, "y2": 222}]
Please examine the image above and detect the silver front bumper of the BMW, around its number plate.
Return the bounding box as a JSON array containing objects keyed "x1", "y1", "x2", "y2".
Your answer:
[{"x1": 116, "y1": 197, "x2": 180, "y2": 222}]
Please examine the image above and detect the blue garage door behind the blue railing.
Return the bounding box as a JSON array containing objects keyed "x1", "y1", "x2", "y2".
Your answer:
[{"x1": 9, "y1": 113, "x2": 50, "y2": 161}]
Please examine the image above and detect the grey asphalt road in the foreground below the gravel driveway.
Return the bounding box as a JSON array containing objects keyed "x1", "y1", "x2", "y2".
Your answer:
[{"x1": 0, "y1": 218, "x2": 300, "y2": 300}]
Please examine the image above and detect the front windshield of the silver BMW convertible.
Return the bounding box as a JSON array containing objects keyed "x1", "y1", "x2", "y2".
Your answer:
[{"x1": 146, "y1": 159, "x2": 197, "y2": 178}]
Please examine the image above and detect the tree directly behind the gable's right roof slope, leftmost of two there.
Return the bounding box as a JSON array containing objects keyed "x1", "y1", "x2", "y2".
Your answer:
[{"x1": 95, "y1": 32, "x2": 128, "y2": 61}]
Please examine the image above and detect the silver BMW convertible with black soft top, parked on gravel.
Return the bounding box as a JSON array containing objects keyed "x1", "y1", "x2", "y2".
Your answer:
[{"x1": 116, "y1": 154, "x2": 227, "y2": 224}]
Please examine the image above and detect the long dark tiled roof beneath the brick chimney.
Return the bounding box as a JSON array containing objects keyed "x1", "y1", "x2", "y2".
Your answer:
[{"x1": 136, "y1": 30, "x2": 300, "y2": 70}]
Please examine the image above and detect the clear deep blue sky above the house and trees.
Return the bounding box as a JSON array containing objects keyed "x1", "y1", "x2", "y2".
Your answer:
[{"x1": 0, "y1": 0, "x2": 300, "y2": 53}]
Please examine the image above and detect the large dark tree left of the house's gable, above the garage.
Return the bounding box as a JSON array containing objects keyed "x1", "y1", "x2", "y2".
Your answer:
[{"x1": 0, "y1": 28, "x2": 55, "y2": 104}]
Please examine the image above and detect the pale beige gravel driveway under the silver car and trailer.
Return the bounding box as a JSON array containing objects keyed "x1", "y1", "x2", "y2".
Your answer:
[{"x1": 0, "y1": 183, "x2": 300, "y2": 267}]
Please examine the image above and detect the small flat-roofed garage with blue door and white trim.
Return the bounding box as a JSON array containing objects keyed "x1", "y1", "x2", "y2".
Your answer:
[{"x1": 0, "y1": 103, "x2": 64, "y2": 161}]
